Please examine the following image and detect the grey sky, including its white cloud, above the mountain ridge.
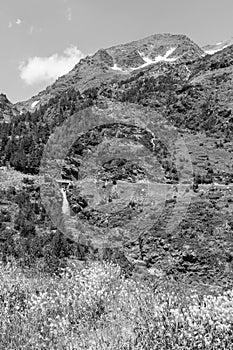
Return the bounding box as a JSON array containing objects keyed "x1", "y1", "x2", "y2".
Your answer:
[{"x1": 0, "y1": 0, "x2": 233, "y2": 103}]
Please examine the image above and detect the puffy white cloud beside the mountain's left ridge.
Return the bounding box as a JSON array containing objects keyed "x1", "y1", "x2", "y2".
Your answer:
[{"x1": 19, "y1": 46, "x2": 85, "y2": 85}]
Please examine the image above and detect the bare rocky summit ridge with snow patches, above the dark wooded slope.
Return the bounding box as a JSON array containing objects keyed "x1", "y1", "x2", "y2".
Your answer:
[{"x1": 16, "y1": 34, "x2": 204, "y2": 111}]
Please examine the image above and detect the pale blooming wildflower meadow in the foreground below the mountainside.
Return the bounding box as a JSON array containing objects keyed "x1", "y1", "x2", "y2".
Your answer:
[{"x1": 0, "y1": 262, "x2": 233, "y2": 350}]
